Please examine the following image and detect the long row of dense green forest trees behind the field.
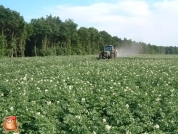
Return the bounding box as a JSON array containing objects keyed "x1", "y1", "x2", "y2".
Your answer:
[{"x1": 0, "y1": 5, "x2": 178, "y2": 57}]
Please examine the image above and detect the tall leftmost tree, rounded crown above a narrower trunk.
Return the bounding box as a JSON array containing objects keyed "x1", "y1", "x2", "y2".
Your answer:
[{"x1": 0, "y1": 5, "x2": 25, "y2": 57}]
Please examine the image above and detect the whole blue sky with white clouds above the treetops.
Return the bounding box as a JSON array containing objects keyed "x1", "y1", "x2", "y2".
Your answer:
[{"x1": 0, "y1": 0, "x2": 178, "y2": 47}]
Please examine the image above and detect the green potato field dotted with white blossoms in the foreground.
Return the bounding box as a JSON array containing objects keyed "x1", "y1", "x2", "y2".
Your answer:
[{"x1": 0, "y1": 55, "x2": 178, "y2": 134}]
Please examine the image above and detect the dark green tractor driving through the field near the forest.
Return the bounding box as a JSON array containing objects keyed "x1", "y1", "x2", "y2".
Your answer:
[{"x1": 99, "y1": 45, "x2": 117, "y2": 59}]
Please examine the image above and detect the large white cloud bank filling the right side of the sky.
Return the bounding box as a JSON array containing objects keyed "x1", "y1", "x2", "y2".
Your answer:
[{"x1": 47, "y1": 0, "x2": 178, "y2": 46}]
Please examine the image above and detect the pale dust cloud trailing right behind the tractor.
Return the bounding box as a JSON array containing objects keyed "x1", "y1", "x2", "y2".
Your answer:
[{"x1": 116, "y1": 45, "x2": 142, "y2": 57}]
